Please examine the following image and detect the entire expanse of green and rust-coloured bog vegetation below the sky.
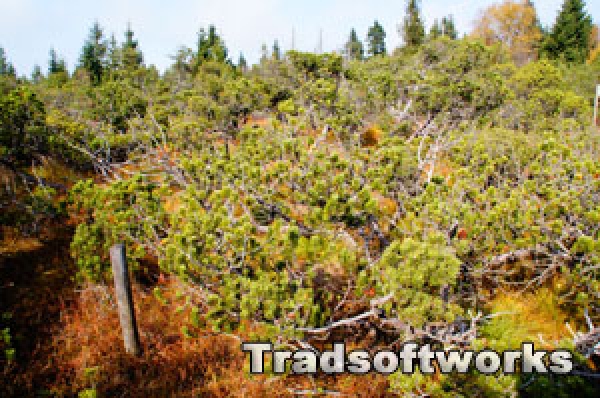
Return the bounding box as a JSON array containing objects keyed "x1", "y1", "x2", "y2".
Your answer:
[{"x1": 0, "y1": 0, "x2": 600, "y2": 397}]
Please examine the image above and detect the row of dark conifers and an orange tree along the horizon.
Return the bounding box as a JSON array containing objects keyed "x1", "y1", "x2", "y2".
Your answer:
[{"x1": 0, "y1": 0, "x2": 599, "y2": 84}]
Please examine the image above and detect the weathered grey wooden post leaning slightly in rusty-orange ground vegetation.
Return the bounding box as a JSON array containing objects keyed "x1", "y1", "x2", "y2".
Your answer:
[{"x1": 110, "y1": 243, "x2": 142, "y2": 356}]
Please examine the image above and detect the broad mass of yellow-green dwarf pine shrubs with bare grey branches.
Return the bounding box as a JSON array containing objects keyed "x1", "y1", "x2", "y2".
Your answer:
[{"x1": 0, "y1": 23, "x2": 600, "y2": 396}]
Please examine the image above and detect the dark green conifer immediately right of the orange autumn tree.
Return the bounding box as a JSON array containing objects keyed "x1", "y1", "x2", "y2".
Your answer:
[{"x1": 542, "y1": 0, "x2": 592, "y2": 63}]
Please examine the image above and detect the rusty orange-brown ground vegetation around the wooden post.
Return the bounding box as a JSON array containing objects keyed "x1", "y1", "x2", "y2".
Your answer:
[{"x1": 0, "y1": 230, "x2": 389, "y2": 397}]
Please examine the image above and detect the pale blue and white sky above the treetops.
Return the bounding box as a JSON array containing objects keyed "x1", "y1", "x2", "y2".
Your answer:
[{"x1": 0, "y1": 0, "x2": 600, "y2": 75}]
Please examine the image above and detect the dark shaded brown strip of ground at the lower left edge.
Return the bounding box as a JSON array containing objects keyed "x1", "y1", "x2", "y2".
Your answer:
[{"x1": 0, "y1": 227, "x2": 75, "y2": 397}]
